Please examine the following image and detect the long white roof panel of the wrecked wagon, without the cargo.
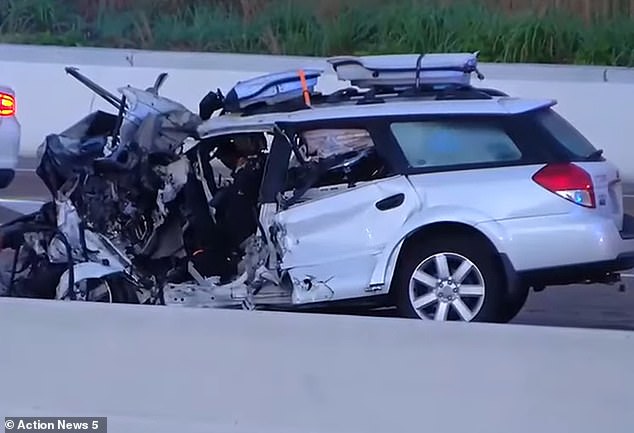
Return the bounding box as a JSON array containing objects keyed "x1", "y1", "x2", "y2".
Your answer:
[{"x1": 198, "y1": 96, "x2": 557, "y2": 137}]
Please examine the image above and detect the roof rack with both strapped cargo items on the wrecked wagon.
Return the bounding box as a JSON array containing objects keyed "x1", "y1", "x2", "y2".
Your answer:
[{"x1": 207, "y1": 52, "x2": 498, "y2": 116}]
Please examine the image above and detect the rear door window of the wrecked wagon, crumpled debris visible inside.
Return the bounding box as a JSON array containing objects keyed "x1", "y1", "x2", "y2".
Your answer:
[{"x1": 289, "y1": 128, "x2": 387, "y2": 188}]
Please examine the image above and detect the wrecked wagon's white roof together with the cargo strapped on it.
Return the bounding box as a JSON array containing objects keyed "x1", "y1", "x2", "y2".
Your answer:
[{"x1": 198, "y1": 52, "x2": 556, "y2": 137}]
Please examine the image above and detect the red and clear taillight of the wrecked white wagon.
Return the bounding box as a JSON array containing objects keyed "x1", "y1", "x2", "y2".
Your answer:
[{"x1": 533, "y1": 164, "x2": 596, "y2": 208}]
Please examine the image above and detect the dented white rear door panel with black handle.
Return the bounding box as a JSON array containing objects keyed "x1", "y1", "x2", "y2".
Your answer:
[{"x1": 275, "y1": 176, "x2": 420, "y2": 301}]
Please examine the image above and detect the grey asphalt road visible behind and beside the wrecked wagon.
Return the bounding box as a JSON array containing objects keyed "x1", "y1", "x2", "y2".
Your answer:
[{"x1": 0, "y1": 160, "x2": 634, "y2": 330}]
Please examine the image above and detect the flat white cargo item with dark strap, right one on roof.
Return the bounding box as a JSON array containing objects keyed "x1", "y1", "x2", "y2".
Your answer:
[{"x1": 327, "y1": 53, "x2": 481, "y2": 88}]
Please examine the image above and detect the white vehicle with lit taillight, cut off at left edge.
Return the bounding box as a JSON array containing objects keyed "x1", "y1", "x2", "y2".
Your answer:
[{"x1": 0, "y1": 84, "x2": 21, "y2": 189}]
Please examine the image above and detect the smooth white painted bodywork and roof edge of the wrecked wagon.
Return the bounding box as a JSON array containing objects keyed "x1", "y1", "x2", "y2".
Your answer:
[{"x1": 203, "y1": 97, "x2": 634, "y2": 276}]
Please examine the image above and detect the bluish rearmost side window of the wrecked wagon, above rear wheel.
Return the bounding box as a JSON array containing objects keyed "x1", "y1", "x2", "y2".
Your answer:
[{"x1": 390, "y1": 119, "x2": 522, "y2": 168}]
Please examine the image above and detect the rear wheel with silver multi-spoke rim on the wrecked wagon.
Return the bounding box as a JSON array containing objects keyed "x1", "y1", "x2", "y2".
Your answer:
[{"x1": 392, "y1": 235, "x2": 507, "y2": 322}]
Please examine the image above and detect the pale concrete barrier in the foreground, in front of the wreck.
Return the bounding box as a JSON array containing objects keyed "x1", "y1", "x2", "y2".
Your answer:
[{"x1": 0, "y1": 298, "x2": 634, "y2": 433}]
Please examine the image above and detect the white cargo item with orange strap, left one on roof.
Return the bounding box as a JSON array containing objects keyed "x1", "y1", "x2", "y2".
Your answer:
[{"x1": 224, "y1": 69, "x2": 324, "y2": 112}]
